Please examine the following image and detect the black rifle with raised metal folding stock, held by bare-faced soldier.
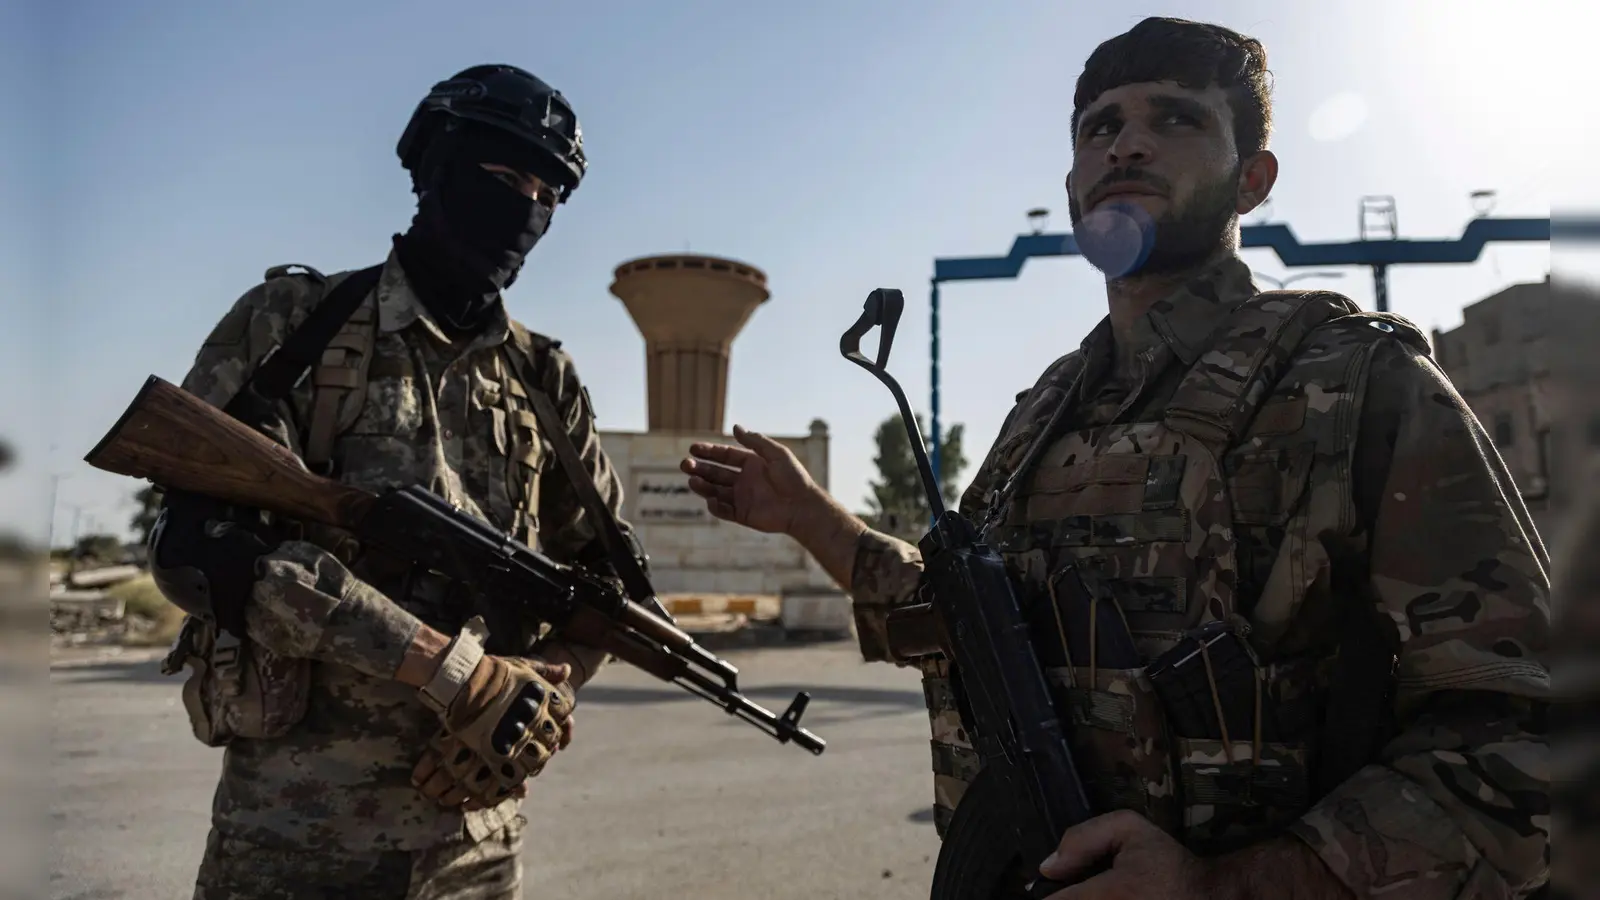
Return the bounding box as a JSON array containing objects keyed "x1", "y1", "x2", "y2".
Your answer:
[{"x1": 838, "y1": 288, "x2": 1093, "y2": 900}]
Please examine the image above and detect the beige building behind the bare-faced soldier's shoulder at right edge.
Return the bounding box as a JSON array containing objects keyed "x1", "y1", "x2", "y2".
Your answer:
[{"x1": 1434, "y1": 275, "x2": 1600, "y2": 549}]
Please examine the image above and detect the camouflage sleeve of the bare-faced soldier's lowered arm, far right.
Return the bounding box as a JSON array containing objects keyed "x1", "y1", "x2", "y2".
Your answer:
[{"x1": 1291, "y1": 341, "x2": 1550, "y2": 900}]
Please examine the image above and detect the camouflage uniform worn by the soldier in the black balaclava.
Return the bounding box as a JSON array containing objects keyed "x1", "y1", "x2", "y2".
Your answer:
[{"x1": 182, "y1": 243, "x2": 626, "y2": 898}]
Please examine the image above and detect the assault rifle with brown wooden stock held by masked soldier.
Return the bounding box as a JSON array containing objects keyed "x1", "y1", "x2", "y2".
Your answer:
[{"x1": 85, "y1": 375, "x2": 827, "y2": 754}]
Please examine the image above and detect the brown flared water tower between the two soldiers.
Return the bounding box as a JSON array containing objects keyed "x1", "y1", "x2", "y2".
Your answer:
[{"x1": 611, "y1": 253, "x2": 771, "y2": 434}]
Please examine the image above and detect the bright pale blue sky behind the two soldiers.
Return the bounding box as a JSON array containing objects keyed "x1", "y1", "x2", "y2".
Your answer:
[{"x1": 0, "y1": 0, "x2": 1600, "y2": 543}]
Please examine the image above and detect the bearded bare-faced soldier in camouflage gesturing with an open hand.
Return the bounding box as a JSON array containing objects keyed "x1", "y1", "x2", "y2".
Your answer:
[{"x1": 683, "y1": 19, "x2": 1549, "y2": 900}]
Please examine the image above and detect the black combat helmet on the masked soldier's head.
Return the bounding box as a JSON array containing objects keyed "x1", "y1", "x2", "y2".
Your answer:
[{"x1": 395, "y1": 66, "x2": 589, "y2": 203}]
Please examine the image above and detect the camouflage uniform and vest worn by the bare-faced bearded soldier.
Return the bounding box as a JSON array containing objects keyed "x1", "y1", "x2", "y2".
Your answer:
[{"x1": 851, "y1": 256, "x2": 1550, "y2": 900}]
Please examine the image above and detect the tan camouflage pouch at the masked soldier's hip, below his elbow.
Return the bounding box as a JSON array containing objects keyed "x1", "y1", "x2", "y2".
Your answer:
[{"x1": 162, "y1": 615, "x2": 310, "y2": 746}]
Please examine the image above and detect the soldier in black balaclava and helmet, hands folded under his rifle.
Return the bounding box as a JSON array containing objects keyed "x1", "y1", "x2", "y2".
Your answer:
[{"x1": 150, "y1": 66, "x2": 637, "y2": 900}]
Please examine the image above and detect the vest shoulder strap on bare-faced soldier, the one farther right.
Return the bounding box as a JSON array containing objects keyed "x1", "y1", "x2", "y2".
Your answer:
[{"x1": 1163, "y1": 290, "x2": 1360, "y2": 450}]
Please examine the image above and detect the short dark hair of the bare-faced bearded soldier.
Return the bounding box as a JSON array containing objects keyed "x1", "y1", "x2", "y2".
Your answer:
[{"x1": 1072, "y1": 16, "x2": 1272, "y2": 159}]
